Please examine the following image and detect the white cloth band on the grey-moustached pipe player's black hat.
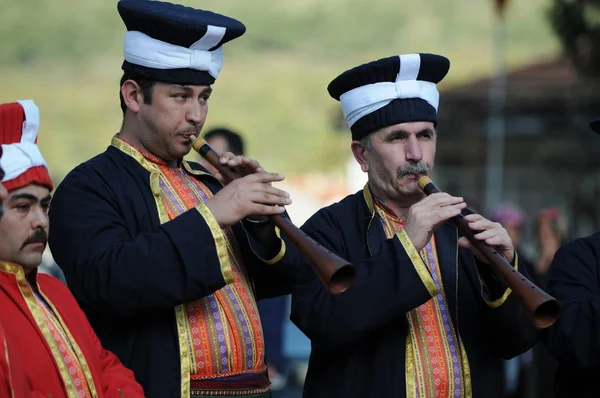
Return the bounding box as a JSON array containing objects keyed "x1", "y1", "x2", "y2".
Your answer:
[{"x1": 340, "y1": 54, "x2": 440, "y2": 127}]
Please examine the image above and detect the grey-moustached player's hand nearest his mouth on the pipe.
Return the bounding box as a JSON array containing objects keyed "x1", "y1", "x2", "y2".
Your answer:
[{"x1": 404, "y1": 192, "x2": 467, "y2": 251}]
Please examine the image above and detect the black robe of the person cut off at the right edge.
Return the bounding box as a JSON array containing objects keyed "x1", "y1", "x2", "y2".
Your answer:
[{"x1": 542, "y1": 232, "x2": 600, "y2": 398}]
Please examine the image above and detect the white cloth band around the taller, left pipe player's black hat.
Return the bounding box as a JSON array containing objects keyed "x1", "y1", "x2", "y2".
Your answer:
[{"x1": 123, "y1": 25, "x2": 226, "y2": 79}]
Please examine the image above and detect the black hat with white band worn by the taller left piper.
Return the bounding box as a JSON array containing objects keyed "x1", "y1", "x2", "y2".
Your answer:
[{"x1": 117, "y1": 0, "x2": 246, "y2": 85}]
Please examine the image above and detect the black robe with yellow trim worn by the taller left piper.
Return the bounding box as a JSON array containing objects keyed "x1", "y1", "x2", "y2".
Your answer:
[{"x1": 49, "y1": 140, "x2": 306, "y2": 398}]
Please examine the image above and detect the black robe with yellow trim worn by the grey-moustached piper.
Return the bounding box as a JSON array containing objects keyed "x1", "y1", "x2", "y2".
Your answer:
[{"x1": 291, "y1": 188, "x2": 539, "y2": 398}]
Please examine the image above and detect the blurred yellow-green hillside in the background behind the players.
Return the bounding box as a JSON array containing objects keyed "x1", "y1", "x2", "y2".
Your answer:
[{"x1": 0, "y1": 0, "x2": 559, "y2": 180}]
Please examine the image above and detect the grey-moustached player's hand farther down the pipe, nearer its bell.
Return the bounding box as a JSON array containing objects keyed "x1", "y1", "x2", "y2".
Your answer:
[{"x1": 458, "y1": 214, "x2": 515, "y2": 264}]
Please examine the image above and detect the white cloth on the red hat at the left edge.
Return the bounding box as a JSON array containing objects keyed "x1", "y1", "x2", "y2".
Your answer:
[{"x1": 0, "y1": 100, "x2": 48, "y2": 182}]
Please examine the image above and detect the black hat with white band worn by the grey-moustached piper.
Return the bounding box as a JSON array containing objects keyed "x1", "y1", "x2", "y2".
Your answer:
[{"x1": 327, "y1": 54, "x2": 450, "y2": 140}]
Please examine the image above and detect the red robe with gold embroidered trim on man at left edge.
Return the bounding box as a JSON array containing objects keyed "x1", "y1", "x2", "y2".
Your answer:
[{"x1": 0, "y1": 262, "x2": 144, "y2": 398}]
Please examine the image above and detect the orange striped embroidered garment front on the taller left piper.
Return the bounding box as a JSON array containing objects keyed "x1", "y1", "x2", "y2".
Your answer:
[{"x1": 155, "y1": 164, "x2": 268, "y2": 380}]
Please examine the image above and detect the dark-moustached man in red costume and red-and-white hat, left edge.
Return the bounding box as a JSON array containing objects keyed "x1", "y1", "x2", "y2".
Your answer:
[{"x1": 0, "y1": 100, "x2": 144, "y2": 398}]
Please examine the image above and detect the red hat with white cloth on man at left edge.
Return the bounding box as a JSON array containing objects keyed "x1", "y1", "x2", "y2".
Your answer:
[{"x1": 0, "y1": 100, "x2": 53, "y2": 191}]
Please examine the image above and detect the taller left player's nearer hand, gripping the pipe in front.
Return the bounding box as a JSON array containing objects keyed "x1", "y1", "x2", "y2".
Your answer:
[{"x1": 206, "y1": 172, "x2": 292, "y2": 227}]
